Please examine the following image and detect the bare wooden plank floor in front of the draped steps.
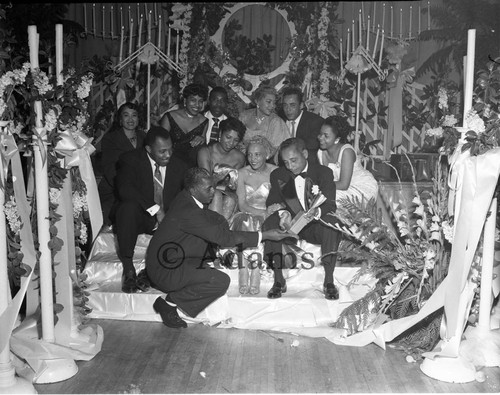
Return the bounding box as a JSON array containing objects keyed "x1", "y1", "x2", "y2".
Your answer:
[{"x1": 35, "y1": 320, "x2": 500, "y2": 394}]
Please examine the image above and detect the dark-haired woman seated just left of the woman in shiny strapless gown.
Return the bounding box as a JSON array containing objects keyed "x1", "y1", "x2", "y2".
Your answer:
[{"x1": 197, "y1": 118, "x2": 246, "y2": 220}]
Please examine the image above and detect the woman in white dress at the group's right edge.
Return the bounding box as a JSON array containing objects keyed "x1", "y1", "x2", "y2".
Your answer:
[{"x1": 318, "y1": 115, "x2": 378, "y2": 203}]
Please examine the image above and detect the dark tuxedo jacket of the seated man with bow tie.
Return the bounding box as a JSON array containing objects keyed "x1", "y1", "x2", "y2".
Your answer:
[{"x1": 266, "y1": 162, "x2": 337, "y2": 222}]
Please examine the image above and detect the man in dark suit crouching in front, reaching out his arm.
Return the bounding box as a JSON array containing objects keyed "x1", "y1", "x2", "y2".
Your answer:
[{"x1": 146, "y1": 167, "x2": 296, "y2": 328}]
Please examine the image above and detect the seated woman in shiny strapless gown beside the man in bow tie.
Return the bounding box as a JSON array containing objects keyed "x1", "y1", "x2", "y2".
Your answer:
[{"x1": 230, "y1": 135, "x2": 278, "y2": 295}]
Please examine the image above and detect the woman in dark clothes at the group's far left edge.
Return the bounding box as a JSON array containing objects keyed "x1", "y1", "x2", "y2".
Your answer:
[{"x1": 99, "y1": 102, "x2": 146, "y2": 226}]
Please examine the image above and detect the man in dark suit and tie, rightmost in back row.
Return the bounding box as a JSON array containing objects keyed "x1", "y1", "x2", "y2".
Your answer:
[{"x1": 281, "y1": 86, "x2": 324, "y2": 162}]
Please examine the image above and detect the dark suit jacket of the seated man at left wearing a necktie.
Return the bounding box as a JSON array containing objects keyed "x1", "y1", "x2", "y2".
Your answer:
[{"x1": 115, "y1": 148, "x2": 188, "y2": 217}]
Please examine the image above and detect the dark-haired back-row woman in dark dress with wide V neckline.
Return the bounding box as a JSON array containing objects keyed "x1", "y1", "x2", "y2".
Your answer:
[{"x1": 160, "y1": 84, "x2": 208, "y2": 167}]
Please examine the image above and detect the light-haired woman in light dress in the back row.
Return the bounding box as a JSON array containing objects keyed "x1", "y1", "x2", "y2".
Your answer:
[{"x1": 240, "y1": 85, "x2": 291, "y2": 163}]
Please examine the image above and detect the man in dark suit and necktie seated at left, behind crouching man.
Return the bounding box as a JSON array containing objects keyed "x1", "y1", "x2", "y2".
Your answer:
[{"x1": 111, "y1": 126, "x2": 187, "y2": 293}]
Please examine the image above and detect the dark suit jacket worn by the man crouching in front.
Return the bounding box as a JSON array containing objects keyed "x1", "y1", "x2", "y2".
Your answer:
[{"x1": 146, "y1": 190, "x2": 258, "y2": 279}]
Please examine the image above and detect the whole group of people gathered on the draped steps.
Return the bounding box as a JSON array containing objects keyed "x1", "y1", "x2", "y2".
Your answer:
[{"x1": 99, "y1": 84, "x2": 377, "y2": 328}]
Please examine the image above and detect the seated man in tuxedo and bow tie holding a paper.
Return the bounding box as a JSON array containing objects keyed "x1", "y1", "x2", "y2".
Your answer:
[{"x1": 262, "y1": 138, "x2": 340, "y2": 299}]
